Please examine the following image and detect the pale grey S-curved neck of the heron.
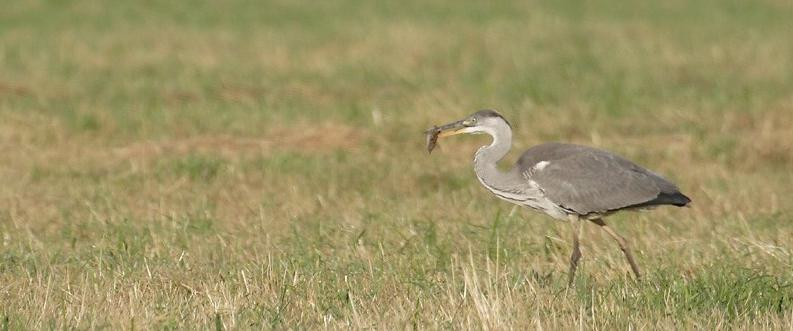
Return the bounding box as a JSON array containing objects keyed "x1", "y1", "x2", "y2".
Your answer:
[{"x1": 474, "y1": 124, "x2": 520, "y2": 190}]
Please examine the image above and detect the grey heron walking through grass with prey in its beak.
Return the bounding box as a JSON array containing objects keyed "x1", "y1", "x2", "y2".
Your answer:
[{"x1": 425, "y1": 110, "x2": 691, "y2": 285}]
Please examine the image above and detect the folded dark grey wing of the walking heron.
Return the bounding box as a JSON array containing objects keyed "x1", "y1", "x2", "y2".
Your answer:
[{"x1": 517, "y1": 143, "x2": 689, "y2": 215}]
